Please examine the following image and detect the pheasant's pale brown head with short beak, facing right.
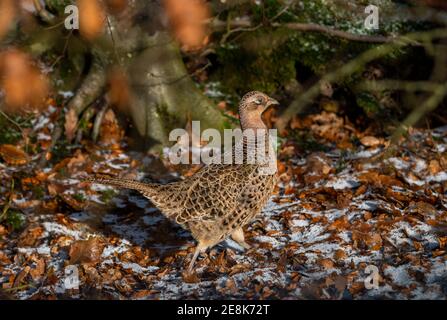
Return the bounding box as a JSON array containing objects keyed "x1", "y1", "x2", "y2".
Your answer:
[{"x1": 239, "y1": 91, "x2": 279, "y2": 130}]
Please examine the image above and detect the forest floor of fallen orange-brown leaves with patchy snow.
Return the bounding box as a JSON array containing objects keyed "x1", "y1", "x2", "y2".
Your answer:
[{"x1": 0, "y1": 103, "x2": 447, "y2": 299}]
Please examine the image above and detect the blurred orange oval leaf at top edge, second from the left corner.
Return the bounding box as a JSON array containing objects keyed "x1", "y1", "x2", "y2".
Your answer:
[{"x1": 77, "y1": 0, "x2": 106, "y2": 40}]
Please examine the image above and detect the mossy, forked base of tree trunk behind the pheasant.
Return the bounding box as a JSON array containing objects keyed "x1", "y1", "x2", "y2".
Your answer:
[{"x1": 40, "y1": 0, "x2": 224, "y2": 149}]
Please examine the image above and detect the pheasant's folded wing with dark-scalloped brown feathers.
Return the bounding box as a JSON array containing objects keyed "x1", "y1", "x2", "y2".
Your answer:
[{"x1": 175, "y1": 164, "x2": 254, "y2": 224}]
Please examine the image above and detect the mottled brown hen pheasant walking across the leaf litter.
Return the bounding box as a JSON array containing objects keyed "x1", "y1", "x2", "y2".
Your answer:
[{"x1": 87, "y1": 91, "x2": 277, "y2": 271}]
